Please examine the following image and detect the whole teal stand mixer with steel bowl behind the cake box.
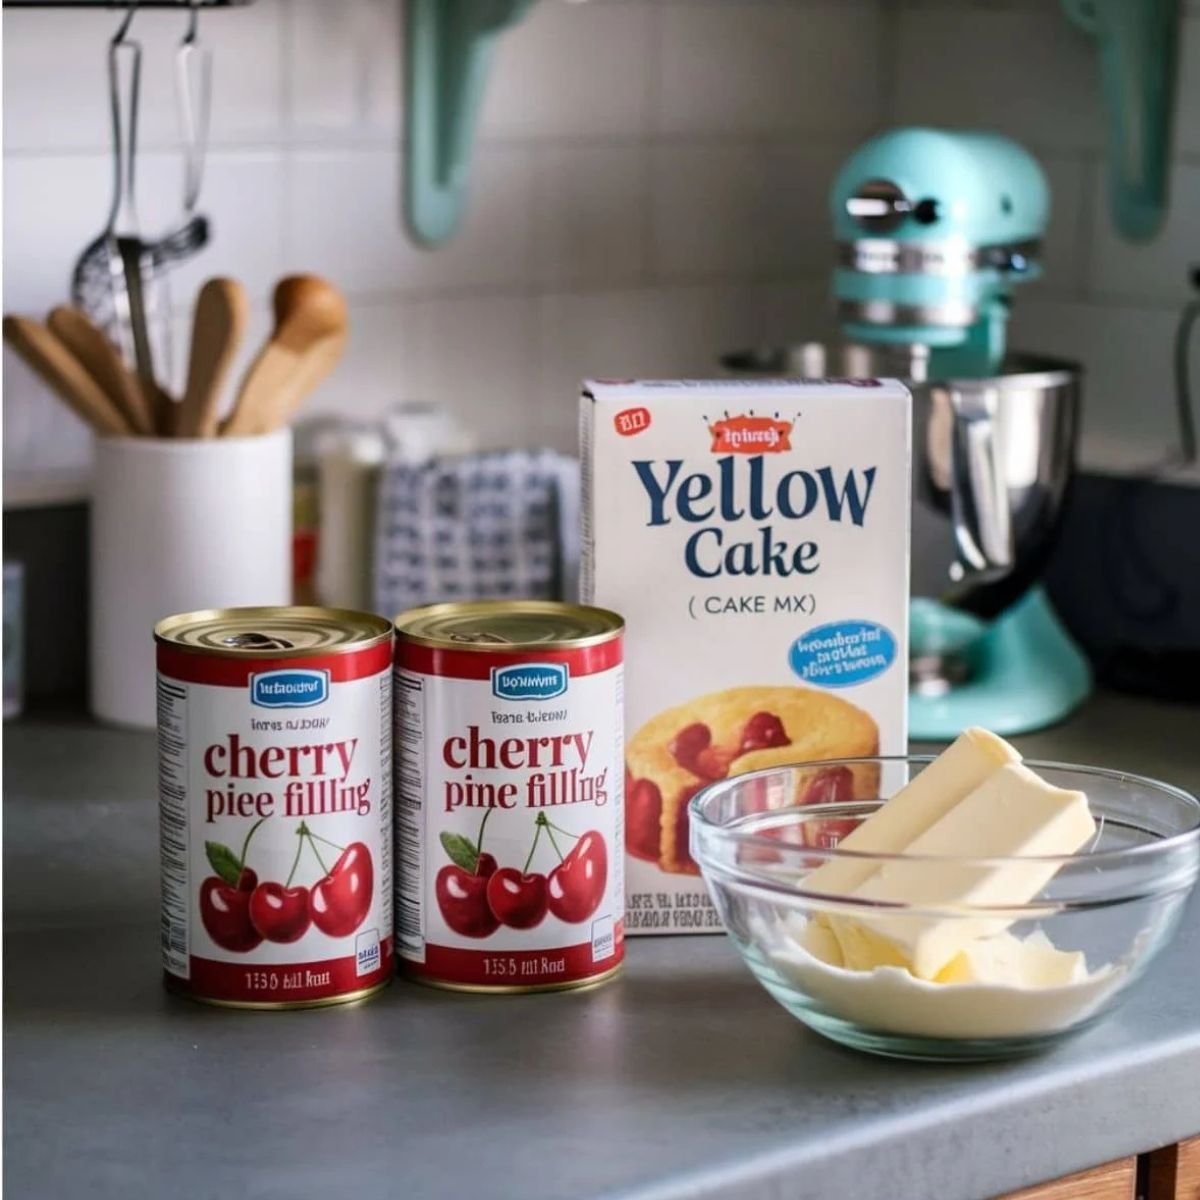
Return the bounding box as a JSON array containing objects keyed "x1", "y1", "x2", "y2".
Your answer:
[{"x1": 722, "y1": 128, "x2": 1091, "y2": 740}]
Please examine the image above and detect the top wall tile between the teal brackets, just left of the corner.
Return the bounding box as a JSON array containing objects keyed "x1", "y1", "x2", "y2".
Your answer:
[{"x1": 655, "y1": 0, "x2": 883, "y2": 134}]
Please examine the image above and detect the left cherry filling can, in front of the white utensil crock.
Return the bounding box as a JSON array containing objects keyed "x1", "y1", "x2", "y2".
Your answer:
[{"x1": 155, "y1": 607, "x2": 394, "y2": 1008}]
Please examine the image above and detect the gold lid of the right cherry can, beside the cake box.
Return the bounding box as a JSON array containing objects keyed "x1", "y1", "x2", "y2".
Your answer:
[{"x1": 396, "y1": 600, "x2": 625, "y2": 652}]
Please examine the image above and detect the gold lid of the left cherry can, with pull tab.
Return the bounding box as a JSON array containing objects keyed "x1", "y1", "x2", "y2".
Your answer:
[{"x1": 154, "y1": 605, "x2": 391, "y2": 659}]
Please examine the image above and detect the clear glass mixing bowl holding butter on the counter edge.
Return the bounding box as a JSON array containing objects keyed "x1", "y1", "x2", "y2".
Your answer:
[{"x1": 690, "y1": 756, "x2": 1200, "y2": 1060}]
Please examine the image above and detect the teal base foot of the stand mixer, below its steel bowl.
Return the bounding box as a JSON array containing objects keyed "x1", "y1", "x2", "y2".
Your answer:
[{"x1": 908, "y1": 588, "x2": 1092, "y2": 742}]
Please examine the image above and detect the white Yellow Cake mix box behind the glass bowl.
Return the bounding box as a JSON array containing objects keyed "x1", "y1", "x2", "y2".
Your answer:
[{"x1": 581, "y1": 379, "x2": 911, "y2": 934}]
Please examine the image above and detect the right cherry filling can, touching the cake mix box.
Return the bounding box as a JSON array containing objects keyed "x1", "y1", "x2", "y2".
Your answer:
[{"x1": 395, "y1": 601, "x2": 625, "y2": 991}]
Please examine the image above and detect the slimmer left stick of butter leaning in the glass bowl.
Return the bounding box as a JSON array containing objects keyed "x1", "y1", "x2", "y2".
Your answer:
[{"x1": 804, "y1": 728, "x2": 1021, "y2": 895}]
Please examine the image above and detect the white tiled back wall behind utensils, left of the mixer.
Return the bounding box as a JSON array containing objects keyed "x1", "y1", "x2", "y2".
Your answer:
[{"x1": 4, "y1": 0, "x2": 887, "y2": 493}]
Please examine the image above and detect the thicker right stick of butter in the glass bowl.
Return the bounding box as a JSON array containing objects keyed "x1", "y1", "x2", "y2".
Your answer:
[{"x1": 822, "y1": 762, "x2": 1096, "y2": 979}]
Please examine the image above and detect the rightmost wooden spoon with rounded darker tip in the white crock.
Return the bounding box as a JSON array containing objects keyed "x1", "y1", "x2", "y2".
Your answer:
[{"x1": 221, "y1": 275, "x2": 347, "y2": 437}]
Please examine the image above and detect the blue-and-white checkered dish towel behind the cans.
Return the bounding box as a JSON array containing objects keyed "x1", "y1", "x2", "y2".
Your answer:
[{"x1": 374, "y1": 450, "x2": 580, "y2": 613}]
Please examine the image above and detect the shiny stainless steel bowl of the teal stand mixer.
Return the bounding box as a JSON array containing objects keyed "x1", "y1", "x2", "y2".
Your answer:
[{"x1": 721, "y1": 342, "x2": 1081, "y2": 618}]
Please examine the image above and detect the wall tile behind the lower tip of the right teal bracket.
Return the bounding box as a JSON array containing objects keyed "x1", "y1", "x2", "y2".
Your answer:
[{"x1": 1090, "y1": 163, "x2": 1200, "y2": 304}]
